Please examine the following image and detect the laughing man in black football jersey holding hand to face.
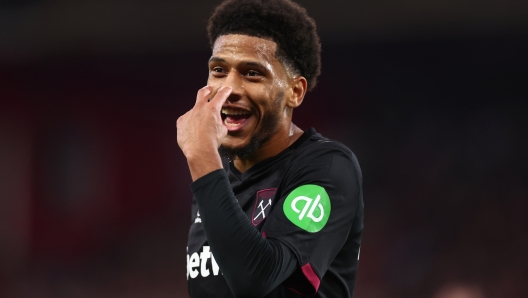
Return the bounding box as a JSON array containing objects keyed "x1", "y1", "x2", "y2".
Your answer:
[{"x1": 177, "y1": 0, "x2": 363, "y2": 298}]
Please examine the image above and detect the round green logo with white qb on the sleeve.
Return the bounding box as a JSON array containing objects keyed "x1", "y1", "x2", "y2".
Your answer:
[{"x1": 282, "y1": 184, "x2": 332, "y2": 233}]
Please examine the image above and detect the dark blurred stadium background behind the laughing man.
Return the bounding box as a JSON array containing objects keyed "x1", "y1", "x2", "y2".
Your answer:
[{"x1": 0, "y1": 0, "x2": 528, "y2": 298}]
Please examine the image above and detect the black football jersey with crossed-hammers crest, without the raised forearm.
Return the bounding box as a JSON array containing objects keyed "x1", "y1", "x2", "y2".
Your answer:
[{"x1": 187, "y1": 128, "x2": 363, "y2": 298}]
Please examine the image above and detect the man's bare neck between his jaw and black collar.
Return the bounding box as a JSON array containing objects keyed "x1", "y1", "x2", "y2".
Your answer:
[{"x1": 233, "y1": 122, "x2": 303, "y2": 173}]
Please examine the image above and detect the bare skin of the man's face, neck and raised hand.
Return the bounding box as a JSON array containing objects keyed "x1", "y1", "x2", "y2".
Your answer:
[{"x1": 176, "y1": 34, "x2": 307, "y2": 181}]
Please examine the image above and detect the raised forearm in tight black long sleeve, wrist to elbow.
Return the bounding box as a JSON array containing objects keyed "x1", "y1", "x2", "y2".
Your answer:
[{"x1": 191, "y1": 170, "x2": 297, "y2": 297}]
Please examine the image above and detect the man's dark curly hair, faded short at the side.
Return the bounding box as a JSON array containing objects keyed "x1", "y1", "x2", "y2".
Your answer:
[{"x1": 207, "y1": 0, "x2": 321, "y2": 90}]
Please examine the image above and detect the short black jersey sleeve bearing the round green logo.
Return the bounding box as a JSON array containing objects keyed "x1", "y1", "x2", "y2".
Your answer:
[{"x1": 262, "y1": 146, "x2": 362, "y2": 295}]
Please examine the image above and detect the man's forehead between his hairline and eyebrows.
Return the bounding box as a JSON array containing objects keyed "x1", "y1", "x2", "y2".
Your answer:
[{"x1": 213, "y1": 34, "x2": 277, "y2": 63}]
